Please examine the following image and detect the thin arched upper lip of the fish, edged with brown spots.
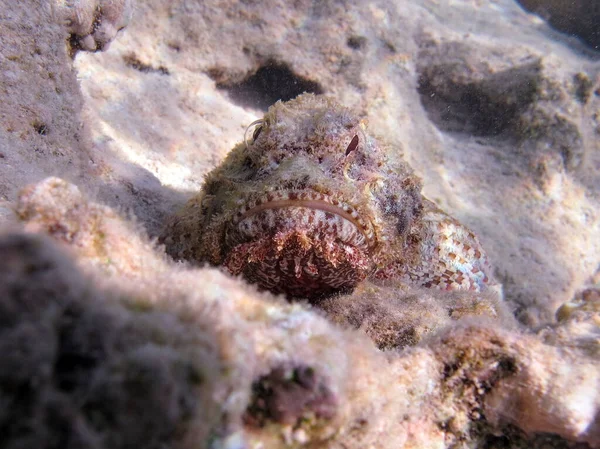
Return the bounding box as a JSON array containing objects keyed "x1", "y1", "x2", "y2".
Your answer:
[{"x1": 232, "y1": 189, "x2": 375, "y2": 248}]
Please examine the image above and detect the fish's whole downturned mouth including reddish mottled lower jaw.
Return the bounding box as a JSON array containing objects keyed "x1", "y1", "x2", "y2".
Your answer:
[{"x1": 223, "y1": 190, "x2": 375, "y2": 300}]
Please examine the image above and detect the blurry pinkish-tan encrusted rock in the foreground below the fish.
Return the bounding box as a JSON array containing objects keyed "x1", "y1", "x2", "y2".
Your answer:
[{"x1": 0, "y1": 178, "x2": 600, "y2": 448}]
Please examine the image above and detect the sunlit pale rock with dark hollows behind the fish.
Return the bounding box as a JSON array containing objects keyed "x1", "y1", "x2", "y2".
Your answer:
[{"x1": 70, "y1": 0, "x2": 600, "y2": 325}]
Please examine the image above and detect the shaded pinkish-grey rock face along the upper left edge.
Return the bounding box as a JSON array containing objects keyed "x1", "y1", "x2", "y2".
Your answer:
[{"x1": 0, "y1": 0, "x2": 91, "y2": 219}]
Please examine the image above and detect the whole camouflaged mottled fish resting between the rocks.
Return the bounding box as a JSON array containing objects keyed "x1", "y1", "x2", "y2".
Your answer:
[{"x1": 161, "y1": 94, "x2": 494, "y2": 300}]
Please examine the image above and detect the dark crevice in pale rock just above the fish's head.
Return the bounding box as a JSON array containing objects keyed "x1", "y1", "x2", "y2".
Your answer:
[{"x1": 208, "y1": 60, "x2": 324, "y2": 110}]
